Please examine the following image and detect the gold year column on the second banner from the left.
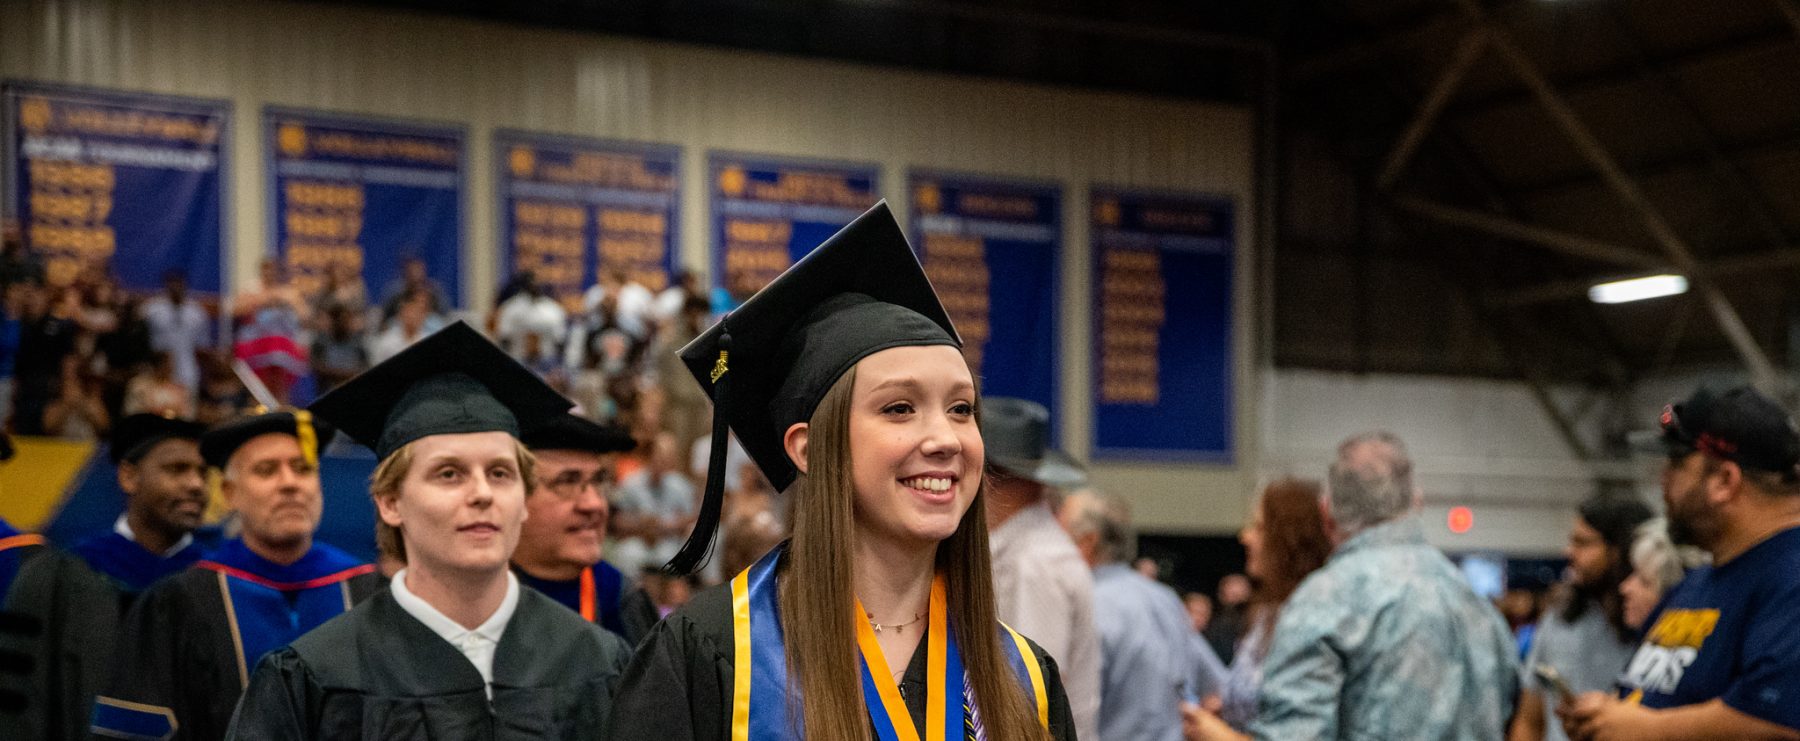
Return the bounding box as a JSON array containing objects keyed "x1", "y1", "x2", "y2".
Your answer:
[{"x1": 281, "y1": 178, "x2": 367, "y2": 295}]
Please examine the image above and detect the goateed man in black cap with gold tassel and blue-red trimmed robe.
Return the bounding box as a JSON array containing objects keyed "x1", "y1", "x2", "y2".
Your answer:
[{"x1": 92, "y1": 412, "x2": 382, "y2": 739}]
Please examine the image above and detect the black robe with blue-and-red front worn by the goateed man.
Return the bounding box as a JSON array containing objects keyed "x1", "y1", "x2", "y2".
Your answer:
[{"x1": 92, "y1": 541, "x2": 385, "y2": 741}]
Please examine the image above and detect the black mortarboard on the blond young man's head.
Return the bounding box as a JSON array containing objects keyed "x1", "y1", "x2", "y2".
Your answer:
[{"x1": 310, "y1": 322, "x2": 574, "y2": 459}]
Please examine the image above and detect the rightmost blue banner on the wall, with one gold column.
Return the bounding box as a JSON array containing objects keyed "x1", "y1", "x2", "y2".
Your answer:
[{"x1": 1089, "y1": 187, "x2": 1235, "y2": 462}]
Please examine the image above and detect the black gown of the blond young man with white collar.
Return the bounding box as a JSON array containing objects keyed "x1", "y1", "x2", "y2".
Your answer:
[{"x1": 227, "y1": 588, "x2": 630, "y2": 741}]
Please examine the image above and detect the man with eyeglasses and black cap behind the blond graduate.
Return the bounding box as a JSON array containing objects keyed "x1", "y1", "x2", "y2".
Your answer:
[{"x1": 513, "y1": 414, "x2": 657, "y2": 646}]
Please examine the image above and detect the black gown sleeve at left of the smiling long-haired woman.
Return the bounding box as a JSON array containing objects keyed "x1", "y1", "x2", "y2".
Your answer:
[{"x1": 608, "y1": 588, "x2": 734, "y2": 741}]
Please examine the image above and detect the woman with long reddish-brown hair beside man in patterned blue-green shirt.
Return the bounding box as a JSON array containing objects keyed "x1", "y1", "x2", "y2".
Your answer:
[{"x1": 1184, "y1": 478, "x2": 1332, "y2": 739}]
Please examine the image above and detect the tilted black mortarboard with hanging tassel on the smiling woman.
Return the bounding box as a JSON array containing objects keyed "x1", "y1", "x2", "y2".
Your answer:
[{"x1": 668, "y1": 201, "x2": 963, "y2": 574}]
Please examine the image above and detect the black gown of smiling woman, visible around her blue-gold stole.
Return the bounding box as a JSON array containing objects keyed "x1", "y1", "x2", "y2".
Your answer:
[{"x1": 610, "y1": 583, "x2": 1075, "y2": 741}]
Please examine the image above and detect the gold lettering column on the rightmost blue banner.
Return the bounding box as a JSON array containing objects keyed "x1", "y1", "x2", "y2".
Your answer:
[{"x1": 1100, "y1": 248, "x2": 1168, "y2": 405}]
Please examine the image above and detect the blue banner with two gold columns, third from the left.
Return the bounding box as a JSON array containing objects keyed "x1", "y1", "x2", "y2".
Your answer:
[{"x1": 493, "y1": 131, "x2": 680, "y2": 313}]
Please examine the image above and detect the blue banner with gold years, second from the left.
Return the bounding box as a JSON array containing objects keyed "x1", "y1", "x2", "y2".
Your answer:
[{"x1": 263, "y1": 108, "x2": 463, "y2": 306}]
